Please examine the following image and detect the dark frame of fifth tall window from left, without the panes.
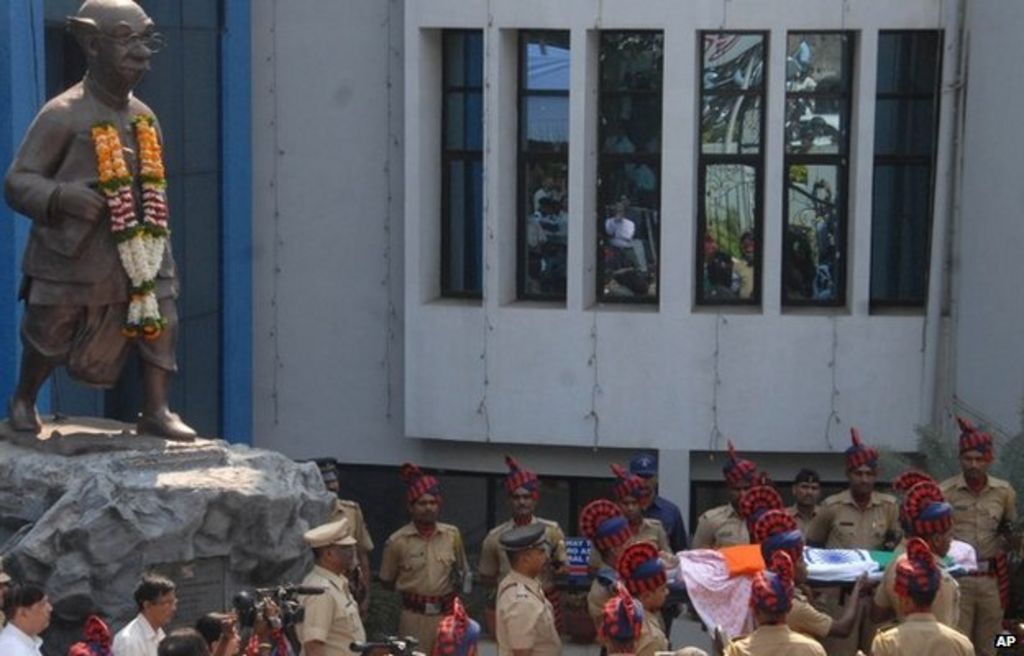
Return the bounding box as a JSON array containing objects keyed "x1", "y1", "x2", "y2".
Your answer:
[{"x1": 779, "y1": 30, "x2": 857, "y2": 308}]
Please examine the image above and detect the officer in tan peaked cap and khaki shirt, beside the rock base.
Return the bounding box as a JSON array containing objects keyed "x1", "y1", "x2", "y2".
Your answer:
[{"x1": 296, "y1": 519, "x2": 367, "y2": 656}]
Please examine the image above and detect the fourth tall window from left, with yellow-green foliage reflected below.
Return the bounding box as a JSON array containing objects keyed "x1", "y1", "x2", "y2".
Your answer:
[{"x1": 695, "y1": 32, "x2": 768, "y2": 305}]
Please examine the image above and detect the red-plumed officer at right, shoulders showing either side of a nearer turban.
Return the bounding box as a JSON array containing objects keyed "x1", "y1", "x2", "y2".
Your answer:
[{"x1": 871, "y1": 475, "x2": 961, "y2": 627}]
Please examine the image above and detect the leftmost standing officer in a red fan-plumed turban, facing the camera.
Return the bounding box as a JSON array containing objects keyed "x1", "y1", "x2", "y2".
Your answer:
[{"x1": 380, "y1": 463, "x2": 469, "y2": 654}]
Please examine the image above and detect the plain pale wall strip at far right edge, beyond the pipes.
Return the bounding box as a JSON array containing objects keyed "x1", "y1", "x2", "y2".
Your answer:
[{"x1": 952, "y1": 0, "x2": 1024, "y2": 435}]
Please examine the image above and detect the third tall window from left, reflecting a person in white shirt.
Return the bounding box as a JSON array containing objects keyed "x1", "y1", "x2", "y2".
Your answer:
[{"x1": 597, "y1": 32, "x2": 664, "y2": 303}]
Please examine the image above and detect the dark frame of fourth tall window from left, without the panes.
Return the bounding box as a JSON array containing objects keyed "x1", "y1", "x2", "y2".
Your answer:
[{"x1": 693, "y1": 30, "x2": 771, "y2": 307}]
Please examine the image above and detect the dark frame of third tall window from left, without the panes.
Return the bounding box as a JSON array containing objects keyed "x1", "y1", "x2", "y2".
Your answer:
[{"x1": 594, "y1": 30, "x2": 665, "y2": 307}]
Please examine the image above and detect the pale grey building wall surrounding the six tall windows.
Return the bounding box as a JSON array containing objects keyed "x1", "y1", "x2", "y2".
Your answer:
[{"x1": 247, "y1": 0, "x2": 956, "y2": 508}]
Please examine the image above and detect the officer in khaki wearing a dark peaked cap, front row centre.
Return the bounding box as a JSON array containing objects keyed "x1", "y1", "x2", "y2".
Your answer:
[{"x1": 496, "y1": 524, "x2": 562, "y2": 656}]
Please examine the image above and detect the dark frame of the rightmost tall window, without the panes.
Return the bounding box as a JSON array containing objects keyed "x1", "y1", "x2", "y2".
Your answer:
[{"x1": 867, "y1": 30, "x2": 945, "y2": 312}]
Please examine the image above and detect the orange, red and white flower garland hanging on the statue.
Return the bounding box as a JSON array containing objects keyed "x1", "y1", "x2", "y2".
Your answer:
[{"x1": 92, "y1": 115, "x2": 170, "y2": 340}]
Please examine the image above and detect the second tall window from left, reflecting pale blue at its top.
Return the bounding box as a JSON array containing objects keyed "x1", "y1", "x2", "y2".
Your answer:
[{"x1": 518, "y1": 32, "x2": 569, "y2": 300}]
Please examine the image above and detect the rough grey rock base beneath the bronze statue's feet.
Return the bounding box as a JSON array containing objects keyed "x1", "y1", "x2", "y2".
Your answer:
[{"x1": 0, "y1": 418, "x2": 334, "y2": 653}]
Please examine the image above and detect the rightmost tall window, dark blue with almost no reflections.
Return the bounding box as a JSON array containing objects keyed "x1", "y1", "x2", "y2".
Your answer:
[{"x1": 871, "y1": 31, "x2": 942, "y2": 307}]
